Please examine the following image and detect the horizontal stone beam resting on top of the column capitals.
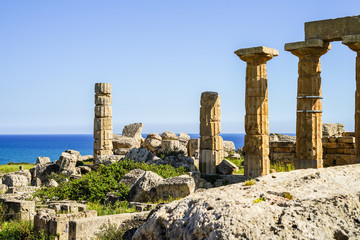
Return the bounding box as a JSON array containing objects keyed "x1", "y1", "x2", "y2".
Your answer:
[{"x1": 305, "y1": 16, "x2": 360, "y2": 41}]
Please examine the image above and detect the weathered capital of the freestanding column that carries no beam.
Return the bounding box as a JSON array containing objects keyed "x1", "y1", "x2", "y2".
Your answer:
[{"x1": 234, "y1": 46, "x2": 279, "y2": 63}]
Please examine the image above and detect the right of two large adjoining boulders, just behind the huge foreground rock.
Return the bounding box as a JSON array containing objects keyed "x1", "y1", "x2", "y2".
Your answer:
[{"x1": 152, "y1": 175, "x2": 195, "y2": 200}]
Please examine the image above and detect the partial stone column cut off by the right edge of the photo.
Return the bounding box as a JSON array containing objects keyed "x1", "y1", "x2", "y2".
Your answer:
[{"x1": 343, "y1": 35, "x2": 360, "y2": 163}]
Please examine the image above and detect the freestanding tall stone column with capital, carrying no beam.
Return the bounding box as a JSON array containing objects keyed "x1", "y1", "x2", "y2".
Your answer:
[{"x1": 235, "y1": 47, "x2": 279, "y2": 177}]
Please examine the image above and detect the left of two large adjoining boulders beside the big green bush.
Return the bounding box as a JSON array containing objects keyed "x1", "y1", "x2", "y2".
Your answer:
[{"x1": 127, "y1": 171, "x2": 163, "y2": 202}]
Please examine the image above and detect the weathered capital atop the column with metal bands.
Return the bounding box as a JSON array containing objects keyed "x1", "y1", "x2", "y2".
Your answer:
[{"x1": 285, "y1": 39, "x2": 331, "y2": 59}]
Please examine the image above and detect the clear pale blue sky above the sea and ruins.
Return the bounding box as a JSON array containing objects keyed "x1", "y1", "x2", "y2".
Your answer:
[{"x1": 0, "y1": 0, "x2": 360, "y2": 134}]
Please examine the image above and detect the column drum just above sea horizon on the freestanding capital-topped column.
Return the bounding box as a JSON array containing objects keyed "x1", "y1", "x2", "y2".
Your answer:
[{"x1": 245, "y1": 113, "x2": 269, "y2": 135}]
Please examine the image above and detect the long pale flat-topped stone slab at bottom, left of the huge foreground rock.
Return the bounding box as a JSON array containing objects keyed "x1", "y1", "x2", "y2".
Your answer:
[{"x1": 69, "y1": 211, "x2": 149, "y2": 240}]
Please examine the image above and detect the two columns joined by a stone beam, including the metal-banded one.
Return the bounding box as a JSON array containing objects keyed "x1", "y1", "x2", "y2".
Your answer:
[{"x1": 285, "y1": 16, "x2": 360, "y2": 169}]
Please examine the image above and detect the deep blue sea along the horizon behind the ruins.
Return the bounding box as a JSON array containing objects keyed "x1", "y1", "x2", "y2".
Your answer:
[{"x1": 0, "y1": 134, "x2": 245, "y2": 164}]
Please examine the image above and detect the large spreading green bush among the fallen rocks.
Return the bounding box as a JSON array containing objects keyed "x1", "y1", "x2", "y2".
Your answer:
[{"x1": 35, "y1": 159, "x2": 185, "y2": 203}]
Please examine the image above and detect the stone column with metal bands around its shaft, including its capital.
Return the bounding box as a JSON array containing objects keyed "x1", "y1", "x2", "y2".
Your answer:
[{"x1": 285, "y1": 39, "x2": 331, "y2": 169}]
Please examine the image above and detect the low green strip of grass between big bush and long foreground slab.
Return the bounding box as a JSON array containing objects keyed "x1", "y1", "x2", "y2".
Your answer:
[{"x1": 87, "y1": 201, "x2": 136, "y2": 216}]
